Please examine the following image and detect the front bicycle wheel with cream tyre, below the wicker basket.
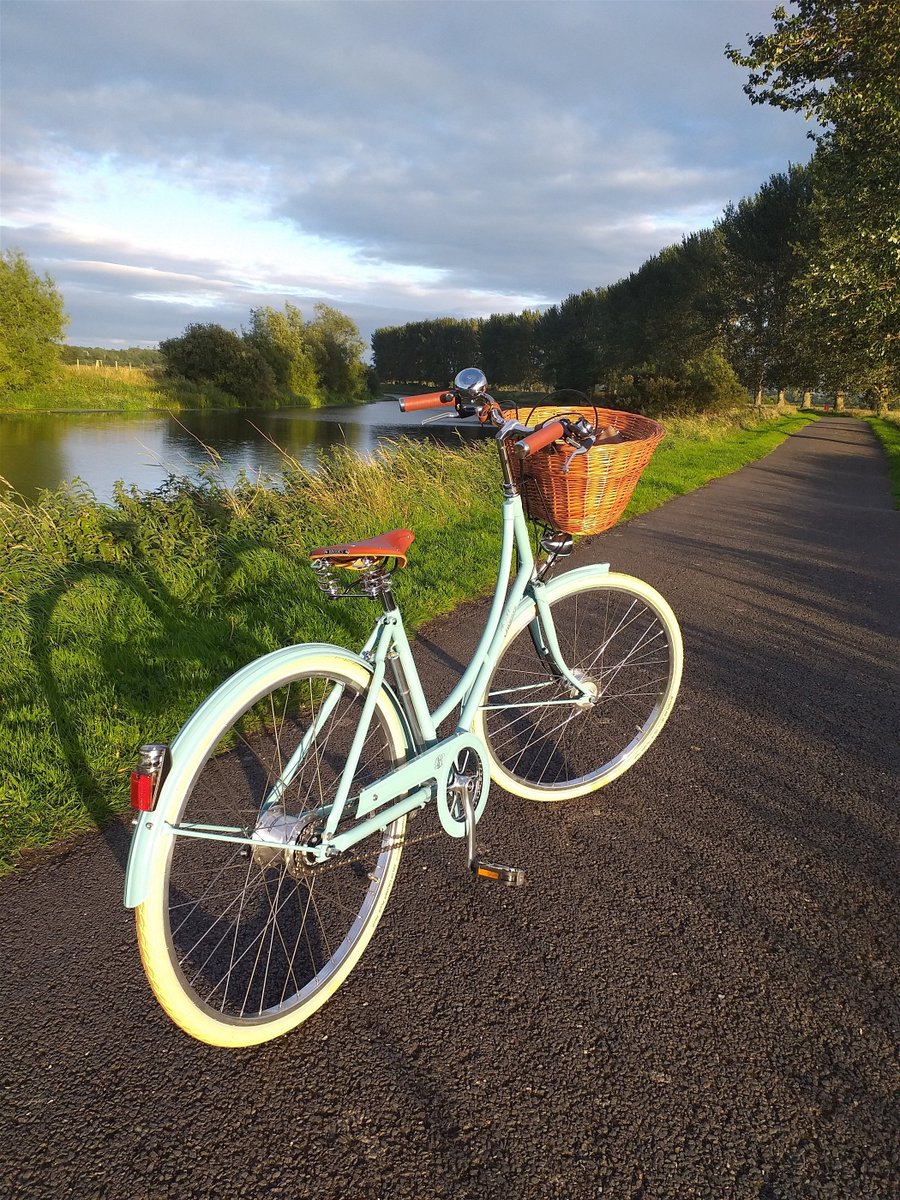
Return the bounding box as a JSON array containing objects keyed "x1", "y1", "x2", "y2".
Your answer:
[{"x1": 475, "y1": 574, "x2": 683, "y2": 800}]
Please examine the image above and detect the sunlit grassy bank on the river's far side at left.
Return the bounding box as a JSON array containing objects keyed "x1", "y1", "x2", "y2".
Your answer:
[{"x1": 0, "y1": 365, "x2": 369, "y2": 413}]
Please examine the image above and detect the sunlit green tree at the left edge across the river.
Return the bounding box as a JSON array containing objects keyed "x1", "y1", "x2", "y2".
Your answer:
[{"x1": 0, "y1": 250, "x2": 68, "y2": 392}]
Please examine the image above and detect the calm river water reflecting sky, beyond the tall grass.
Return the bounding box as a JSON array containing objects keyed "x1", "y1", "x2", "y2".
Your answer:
[{"x1": 0, "y1": 400, "x2": 484, "y2": 500}]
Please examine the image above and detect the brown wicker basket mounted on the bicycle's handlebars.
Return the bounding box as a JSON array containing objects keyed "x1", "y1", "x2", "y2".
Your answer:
[{"x1": 504, "y1": 404, "x2": 666, "y2": 534}]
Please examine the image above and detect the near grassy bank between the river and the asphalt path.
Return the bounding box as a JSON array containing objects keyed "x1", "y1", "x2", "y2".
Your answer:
[{"x1": 0, "y1": 414, "x2": 811, "y2": 870}]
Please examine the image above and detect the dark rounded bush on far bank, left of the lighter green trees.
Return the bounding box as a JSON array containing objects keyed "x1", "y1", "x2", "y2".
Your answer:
[{"x1": 160, "y1": 324, "x2": 276, "y2": 408}]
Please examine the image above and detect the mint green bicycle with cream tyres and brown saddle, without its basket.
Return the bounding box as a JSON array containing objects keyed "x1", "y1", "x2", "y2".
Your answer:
[{"x1": 125, "y1": 368, "x2": 683, "y2": 1046}]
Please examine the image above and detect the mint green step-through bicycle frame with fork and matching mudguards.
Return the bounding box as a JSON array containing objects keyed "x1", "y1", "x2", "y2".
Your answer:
[{"x1": 125, "y1": 472, "x2": 610, "y2": 907}]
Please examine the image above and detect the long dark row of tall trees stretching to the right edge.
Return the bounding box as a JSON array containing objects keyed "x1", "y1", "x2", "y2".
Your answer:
[{"x1": 372, "y1": 0, "x2": 900, "y2": 413}]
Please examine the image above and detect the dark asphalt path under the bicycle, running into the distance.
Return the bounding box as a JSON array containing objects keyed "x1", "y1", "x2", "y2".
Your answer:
[{"x1": 0, "y1": 419, "x2": 900, "y2": 1200}]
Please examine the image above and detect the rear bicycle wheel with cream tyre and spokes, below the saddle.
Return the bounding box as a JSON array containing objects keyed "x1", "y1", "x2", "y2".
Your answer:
[{"x1": 136, "y1": 653, "x2": 406, "y2": 1046}]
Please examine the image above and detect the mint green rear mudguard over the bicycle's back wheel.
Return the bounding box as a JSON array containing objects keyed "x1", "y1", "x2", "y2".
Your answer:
[{"x1": 125, "y1": 642, "x2": 412, "y2": 908}]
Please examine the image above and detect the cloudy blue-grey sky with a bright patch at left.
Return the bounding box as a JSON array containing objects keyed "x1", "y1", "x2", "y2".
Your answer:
[{"x1": 0, "y1": 0, "x2": 812, "y2": 347}]
